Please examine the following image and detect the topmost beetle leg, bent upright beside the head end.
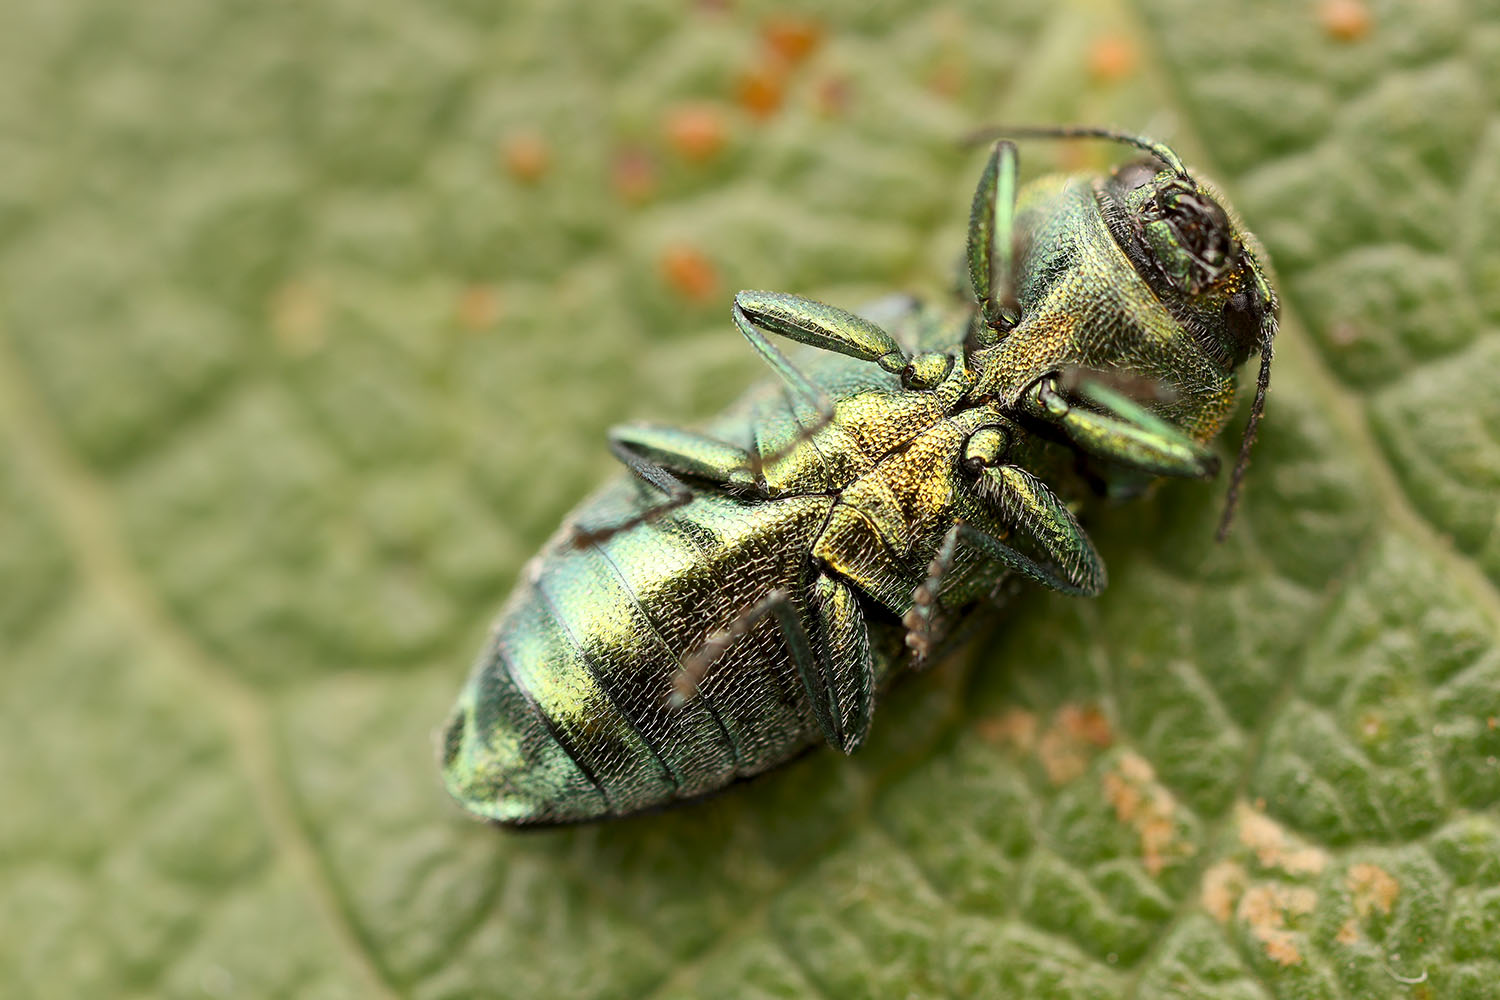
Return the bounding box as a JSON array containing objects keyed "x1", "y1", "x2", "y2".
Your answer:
[{"x1": 969, "y1": 139, "x2": 1020, "y2": 338}]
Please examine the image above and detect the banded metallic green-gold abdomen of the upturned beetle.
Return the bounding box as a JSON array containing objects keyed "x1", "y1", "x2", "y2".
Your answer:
[{"x1": 444, "y1": 481, "x2": 831, "y2": 823}]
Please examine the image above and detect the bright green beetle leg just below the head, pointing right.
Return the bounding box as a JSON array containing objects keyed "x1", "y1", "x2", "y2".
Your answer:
[{"x1": 1019, "y1": 376, "x2": 1218, "y2": 478}]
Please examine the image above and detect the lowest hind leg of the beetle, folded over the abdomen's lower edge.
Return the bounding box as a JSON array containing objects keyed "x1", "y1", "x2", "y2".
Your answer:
[{"x1": 671, "y1": 574, "x2": 875, "y2": 754}]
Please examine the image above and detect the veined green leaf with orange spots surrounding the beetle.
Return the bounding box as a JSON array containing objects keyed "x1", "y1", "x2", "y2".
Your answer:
[{"x1": 0, "y1": 0, "x2": 1500, "y2": 1000}]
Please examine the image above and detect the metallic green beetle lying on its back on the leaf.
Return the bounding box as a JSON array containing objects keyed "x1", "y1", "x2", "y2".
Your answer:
[{"x1": 441, "y1": 127, "x2": 1277, "y2": 825}]
